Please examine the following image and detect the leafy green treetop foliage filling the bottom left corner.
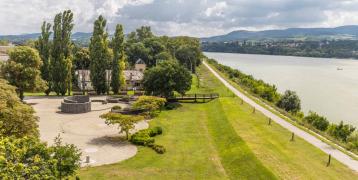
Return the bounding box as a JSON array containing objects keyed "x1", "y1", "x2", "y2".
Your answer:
[{"x1": 0, "y1": 137, "x2": 81, "y2": 179}]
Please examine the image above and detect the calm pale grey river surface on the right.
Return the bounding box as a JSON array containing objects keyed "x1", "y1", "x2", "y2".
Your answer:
[{"x1": 205, "y1": 53, "x2": 358, "y2": 126}]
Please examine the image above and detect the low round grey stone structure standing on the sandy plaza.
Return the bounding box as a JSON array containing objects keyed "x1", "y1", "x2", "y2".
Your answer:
[{"x1": 61, "y1": 96, "x2": 91, "y2": 114}]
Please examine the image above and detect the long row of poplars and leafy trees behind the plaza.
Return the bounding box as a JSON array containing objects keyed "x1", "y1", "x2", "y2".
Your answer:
[{"x1": 3, "y1": 10, "x2": 202, "y2": 99}]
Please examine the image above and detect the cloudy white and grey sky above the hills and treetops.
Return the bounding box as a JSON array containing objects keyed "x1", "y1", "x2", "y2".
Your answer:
[{"x1": 0, "y1": 0, "x2": 358, "y2": 37}]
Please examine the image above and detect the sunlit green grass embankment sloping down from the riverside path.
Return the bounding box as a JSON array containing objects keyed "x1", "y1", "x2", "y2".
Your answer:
[{"x1": 79, "y1": 64, "x2": 357, "y2": 179}]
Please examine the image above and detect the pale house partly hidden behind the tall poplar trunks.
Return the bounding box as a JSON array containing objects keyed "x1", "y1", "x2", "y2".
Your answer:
[{"x1": 76, "y1": 59, "x2": 146, "y2": 91}]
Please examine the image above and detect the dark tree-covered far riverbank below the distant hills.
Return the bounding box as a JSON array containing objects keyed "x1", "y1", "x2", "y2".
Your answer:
[{"x1": 202, "y1": 40, "x2": 358, "y2": 59}]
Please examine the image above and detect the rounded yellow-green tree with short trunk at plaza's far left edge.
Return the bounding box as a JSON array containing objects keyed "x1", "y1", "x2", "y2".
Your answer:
[{"x1": 1, "y1": 46, "x2": 46, "y2": 100}]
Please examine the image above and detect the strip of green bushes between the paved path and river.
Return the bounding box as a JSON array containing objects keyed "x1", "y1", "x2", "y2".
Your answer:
[{"x1": 207, "y1": 59, "x2": 358, "y2": 153}]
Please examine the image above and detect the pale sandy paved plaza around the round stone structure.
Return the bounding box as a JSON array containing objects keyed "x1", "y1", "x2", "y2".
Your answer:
[{"x1": 26, "y1": 96, "x2": 148, "y2": 166}]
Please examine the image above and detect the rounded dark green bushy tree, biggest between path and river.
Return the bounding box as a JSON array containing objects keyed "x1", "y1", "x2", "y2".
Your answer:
[{"x1": 277, "y1": 90, "x2": 301, "y2": 113}]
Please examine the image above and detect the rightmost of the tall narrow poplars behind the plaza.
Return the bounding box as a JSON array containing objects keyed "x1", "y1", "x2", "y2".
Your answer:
[{"x1": 111, "y1": 24, "x2": 124, "y2": 94}]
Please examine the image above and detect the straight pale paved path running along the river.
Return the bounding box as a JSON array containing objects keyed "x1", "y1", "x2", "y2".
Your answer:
[{"x1": 203, "y1": 62, "x2": 358, "y2": 172}]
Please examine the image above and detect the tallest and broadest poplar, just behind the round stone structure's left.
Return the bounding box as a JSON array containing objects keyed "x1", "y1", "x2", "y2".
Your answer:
[{"x1": 51, "y1": 10, "x2": 74, "y2": 95}]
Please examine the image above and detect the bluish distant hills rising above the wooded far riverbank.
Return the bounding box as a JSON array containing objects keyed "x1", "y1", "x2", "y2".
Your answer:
[{"x1": 201, "y1": 25, "x2": 358, "y2": 42}]
